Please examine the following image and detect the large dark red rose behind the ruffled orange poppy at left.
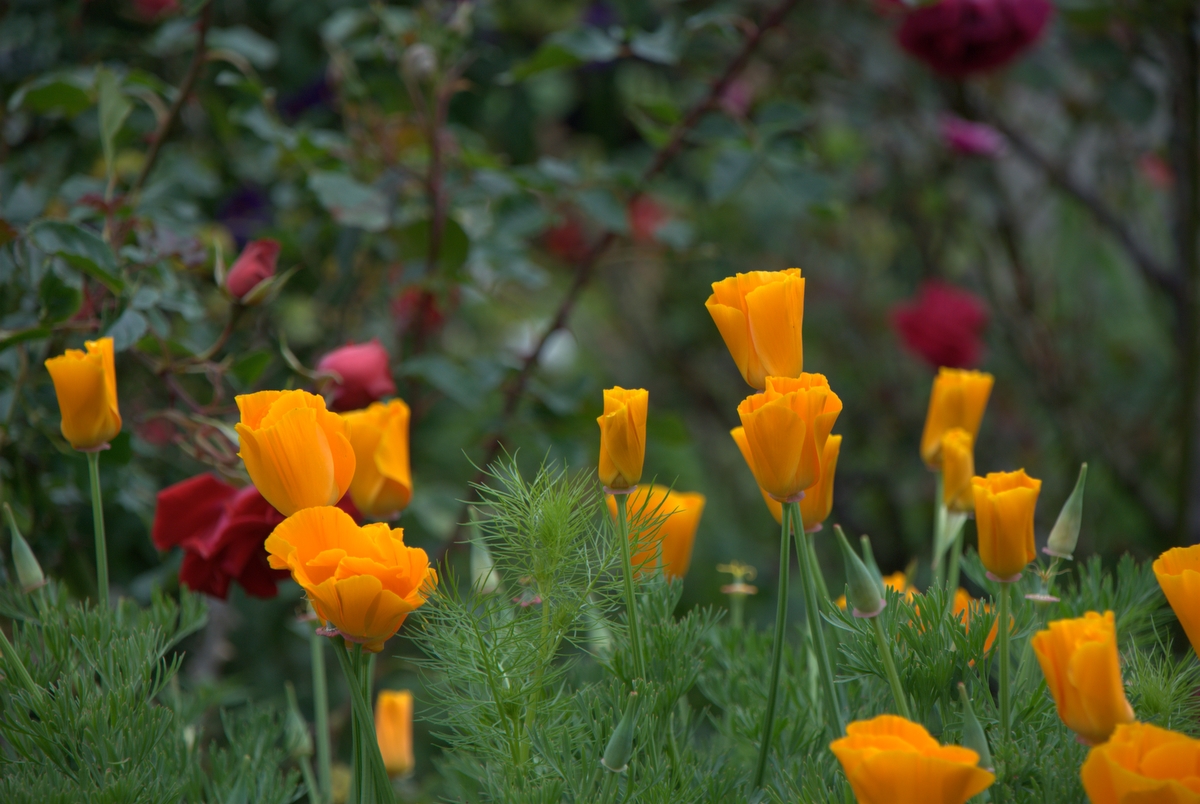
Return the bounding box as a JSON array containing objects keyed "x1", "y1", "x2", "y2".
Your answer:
[{"x1": 151, "y1": 474, "x2": 362, "y2": 600}]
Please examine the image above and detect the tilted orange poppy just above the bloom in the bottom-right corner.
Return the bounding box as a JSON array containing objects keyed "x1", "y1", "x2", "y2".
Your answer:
[{"x1": 1030, "y1": 611, "x2": 1134, "y2": 745}]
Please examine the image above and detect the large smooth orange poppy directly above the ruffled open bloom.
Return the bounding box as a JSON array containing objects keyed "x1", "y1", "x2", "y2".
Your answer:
[{"x1": 236, "y1": 391, "x2": 355, "y2": 516}]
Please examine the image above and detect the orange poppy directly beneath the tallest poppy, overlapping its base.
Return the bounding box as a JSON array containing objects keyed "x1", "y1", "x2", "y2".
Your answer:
[{"x1": 738, "y1": 374, "x2": 841, "y2": 500}]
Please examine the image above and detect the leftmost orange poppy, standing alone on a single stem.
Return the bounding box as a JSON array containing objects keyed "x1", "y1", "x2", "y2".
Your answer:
[{"x1": 46, "y1": 337, "x2": 121, "y2": 452}]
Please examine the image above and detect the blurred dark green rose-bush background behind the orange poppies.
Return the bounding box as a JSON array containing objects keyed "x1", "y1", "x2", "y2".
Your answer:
[{"x1": 0, "y1": 0, "x2": 1200, "y2": 790}]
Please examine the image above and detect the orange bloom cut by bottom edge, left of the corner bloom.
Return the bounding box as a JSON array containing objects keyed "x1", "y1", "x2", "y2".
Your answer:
[{"x1": 829, "y1": 715, "x2": 996, "y2": 804}]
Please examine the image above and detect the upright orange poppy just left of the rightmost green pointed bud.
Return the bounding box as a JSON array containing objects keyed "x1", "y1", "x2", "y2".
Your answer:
[{"x1": 972, "y1": 469, "x2": 1042, "y2": 581}]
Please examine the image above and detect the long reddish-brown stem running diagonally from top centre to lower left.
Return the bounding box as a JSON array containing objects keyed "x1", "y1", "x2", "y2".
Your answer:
[{"x1": 438, "y1": 0, "x2": 799, "y2": 559}]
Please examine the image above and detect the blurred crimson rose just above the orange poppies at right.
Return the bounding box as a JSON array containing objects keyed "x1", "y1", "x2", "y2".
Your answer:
[{"x1": 892, "y1": 280, "x2": 988, "y2": 368}]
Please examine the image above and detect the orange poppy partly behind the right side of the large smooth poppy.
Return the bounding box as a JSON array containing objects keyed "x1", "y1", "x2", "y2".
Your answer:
[{"x1": 342, "y1": 400, "x2": 413, "y2": 517}]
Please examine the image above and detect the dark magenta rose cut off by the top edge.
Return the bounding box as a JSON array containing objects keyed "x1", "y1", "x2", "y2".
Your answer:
[{"x1": 896, "y1": 0, "x2": 1054, "y2": 78}]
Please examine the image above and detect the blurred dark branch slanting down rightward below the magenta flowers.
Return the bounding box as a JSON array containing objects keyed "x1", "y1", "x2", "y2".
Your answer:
[{"x1": 976, "y1": 104, "x2": 1182, "y2": 295}]
